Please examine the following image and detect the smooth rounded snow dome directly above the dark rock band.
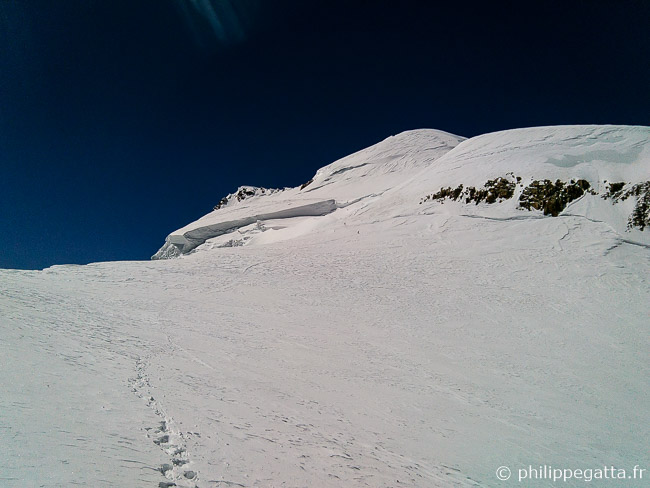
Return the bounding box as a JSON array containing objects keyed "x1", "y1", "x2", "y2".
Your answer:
[{"x1": 400, "y1": 126, "x2": 650, "y2": 198}]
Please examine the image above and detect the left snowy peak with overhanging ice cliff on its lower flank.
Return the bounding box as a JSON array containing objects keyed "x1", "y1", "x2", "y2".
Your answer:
[{"x1": 153, "y1": 130, "x2": 464, "y2": 259}]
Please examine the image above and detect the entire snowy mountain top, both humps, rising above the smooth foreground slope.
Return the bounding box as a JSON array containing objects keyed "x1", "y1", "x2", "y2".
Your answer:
[{"x1": 154, "y1": 126, "x2": 650, "y2": 258}]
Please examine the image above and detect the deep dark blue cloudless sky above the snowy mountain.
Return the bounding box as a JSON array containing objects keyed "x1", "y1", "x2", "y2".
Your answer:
[{"x1": 0, "y1": 0, "x2": 650, "y2": 268}]
